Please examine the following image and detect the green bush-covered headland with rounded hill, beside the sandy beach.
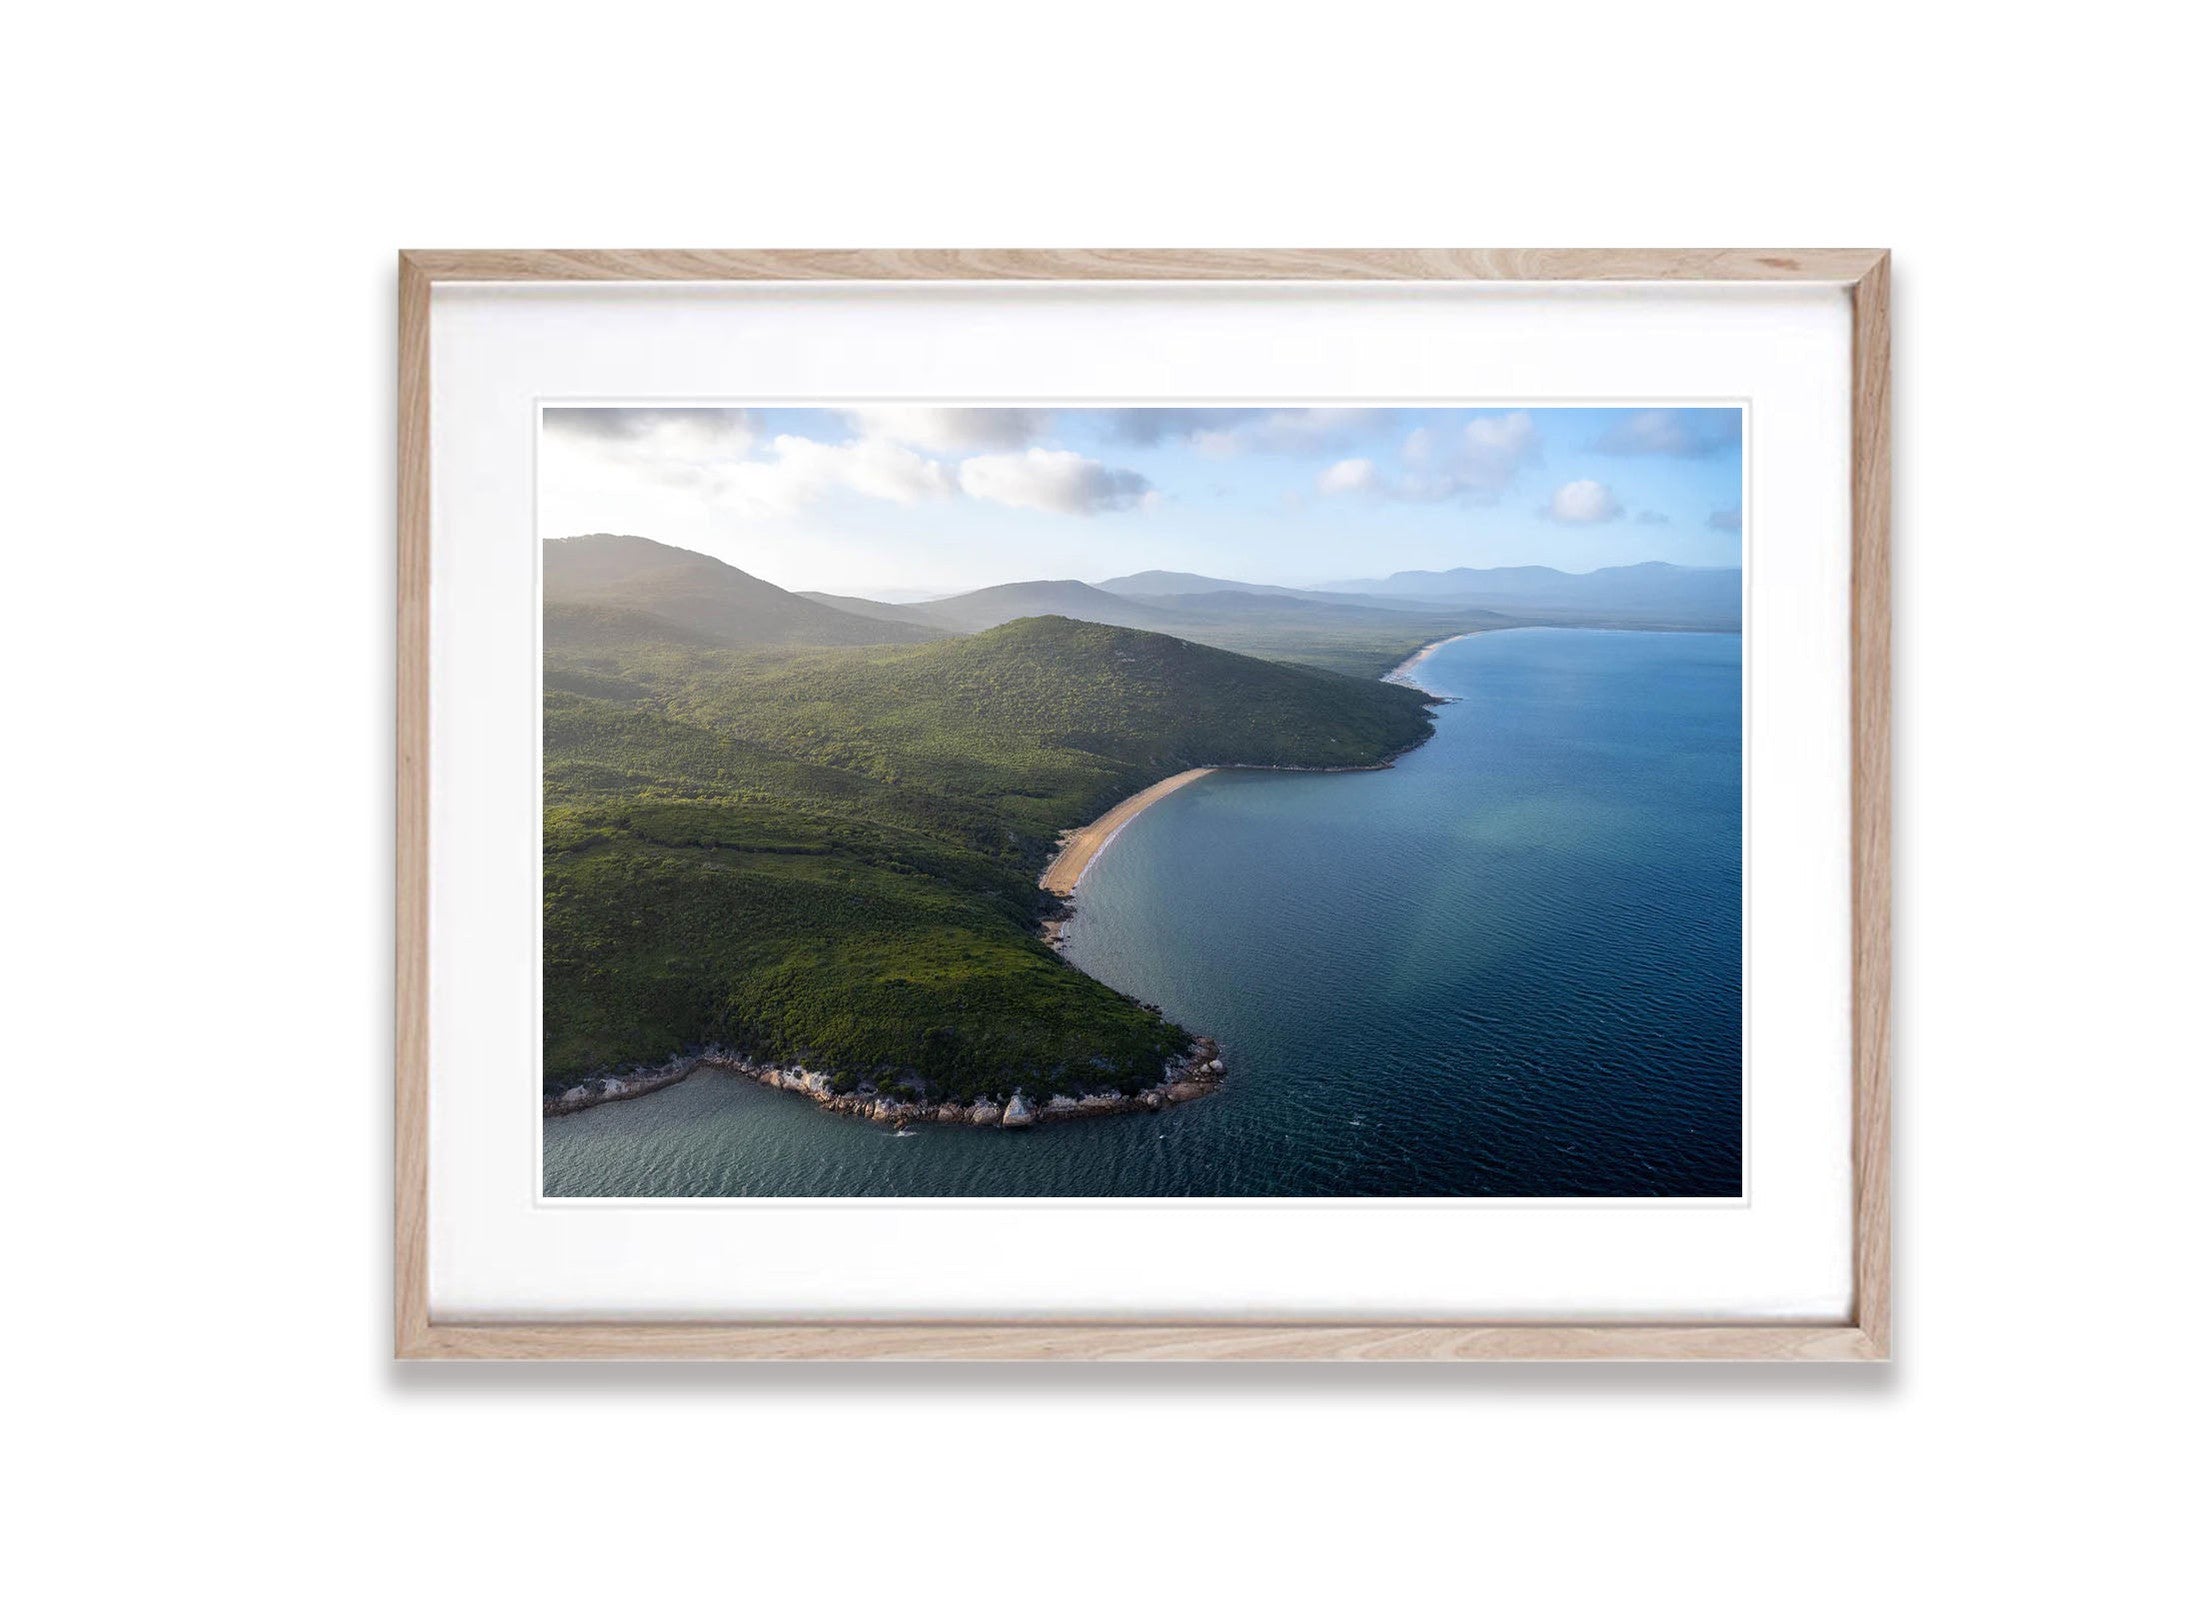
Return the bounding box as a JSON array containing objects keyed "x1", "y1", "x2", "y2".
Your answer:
[{"x1": 543, "y1": 598, "x2": 1429, "y2": 1098}]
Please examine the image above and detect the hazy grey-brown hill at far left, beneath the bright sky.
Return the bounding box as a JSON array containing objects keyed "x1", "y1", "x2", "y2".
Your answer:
[{"x1": 543, "y1": 532, "x2": 939, "y2": 649}]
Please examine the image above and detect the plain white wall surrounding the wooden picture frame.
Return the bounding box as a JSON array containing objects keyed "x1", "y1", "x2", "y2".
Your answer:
[{"x1": 0, "y1": 4, "x2": 2199, "y2": 1592}]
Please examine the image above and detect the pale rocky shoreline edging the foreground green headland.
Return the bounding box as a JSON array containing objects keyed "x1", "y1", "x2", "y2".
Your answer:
[{"x1": 543, "y1": 1038, "x2": 1227, "y2": 1128}]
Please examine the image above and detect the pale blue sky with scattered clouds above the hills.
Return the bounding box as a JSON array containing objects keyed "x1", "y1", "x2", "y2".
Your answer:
[{"x1": 539, "y1": 407, "x2": 1742, "y2": 598}]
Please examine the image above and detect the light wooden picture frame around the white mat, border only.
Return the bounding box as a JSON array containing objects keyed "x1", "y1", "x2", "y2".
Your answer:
[{"x1": 396, "y1": 249, "x2": 1891, "y2": 1361}]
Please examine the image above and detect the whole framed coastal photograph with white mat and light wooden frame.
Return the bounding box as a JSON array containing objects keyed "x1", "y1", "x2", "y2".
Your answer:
[{"x1": 396, "y1": 249, "x2": 1889, "y2": 1359}]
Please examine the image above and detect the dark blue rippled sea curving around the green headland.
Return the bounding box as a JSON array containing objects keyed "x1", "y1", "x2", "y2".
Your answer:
[{"x1": 543, "y1": 629, "x2": 1742, "y2": 1197}]
